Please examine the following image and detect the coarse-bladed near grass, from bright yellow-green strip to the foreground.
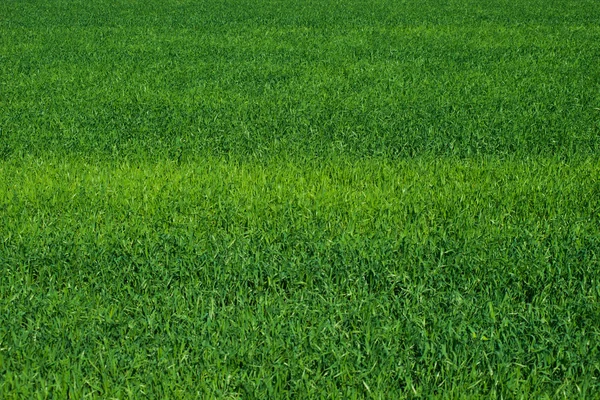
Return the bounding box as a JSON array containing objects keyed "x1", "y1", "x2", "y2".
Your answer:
[{"x1": 0, "y1": 158, "x2": 600, "y2": 398}]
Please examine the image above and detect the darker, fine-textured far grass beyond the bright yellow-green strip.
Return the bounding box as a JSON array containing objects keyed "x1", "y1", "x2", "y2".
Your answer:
[{"x1": 0, "y1": 0, "x2": 600, "y2": 159}]
